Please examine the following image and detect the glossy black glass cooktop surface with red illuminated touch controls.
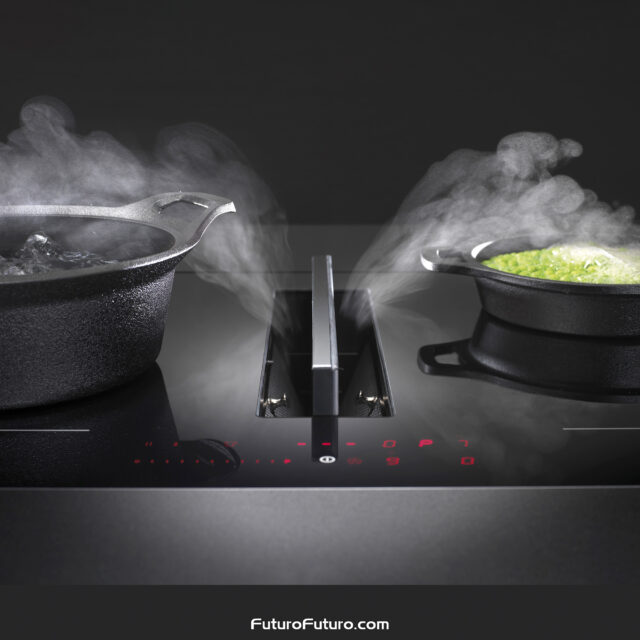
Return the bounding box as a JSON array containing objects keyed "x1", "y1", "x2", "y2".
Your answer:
[{"x1": 0, "y1": 272, "x2": 640, "y2": 487}]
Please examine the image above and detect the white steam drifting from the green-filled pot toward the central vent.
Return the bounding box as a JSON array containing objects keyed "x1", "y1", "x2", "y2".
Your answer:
[{"x1": 349, "y1": 132, "x2": 634, "y2": 318}]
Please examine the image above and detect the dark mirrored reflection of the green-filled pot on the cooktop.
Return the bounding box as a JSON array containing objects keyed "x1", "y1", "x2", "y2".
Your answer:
[{"x1": 418, "y1": 312, "x2": 640, "y2": 402}]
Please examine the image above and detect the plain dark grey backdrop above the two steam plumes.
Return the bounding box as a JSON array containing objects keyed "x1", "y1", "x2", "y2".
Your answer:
[{"x1": 0, "y1": 0, "x2": 640, "y2": 223}]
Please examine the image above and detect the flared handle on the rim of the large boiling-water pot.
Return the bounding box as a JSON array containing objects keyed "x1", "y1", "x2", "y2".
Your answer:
[{"x1": 120, "y1": 191, "x2": 236, "y2": 249}]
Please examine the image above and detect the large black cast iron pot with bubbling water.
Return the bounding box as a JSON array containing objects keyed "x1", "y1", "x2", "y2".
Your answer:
[{"x1": 0, "y1": 193, "x2": 234, "y2": 409}]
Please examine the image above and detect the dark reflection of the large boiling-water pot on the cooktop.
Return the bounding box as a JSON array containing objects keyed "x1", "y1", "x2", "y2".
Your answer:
[{"x1": 0, "y1": 365, "x2": 239, "y2": 486}]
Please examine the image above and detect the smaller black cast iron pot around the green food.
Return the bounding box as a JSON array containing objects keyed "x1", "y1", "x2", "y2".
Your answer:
[{"x1": 422, "y1": 238, "x2": 640, "y2": 337}]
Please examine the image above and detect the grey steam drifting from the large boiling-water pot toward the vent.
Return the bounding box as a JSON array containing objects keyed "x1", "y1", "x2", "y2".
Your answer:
[{"x1": 0, "y1": 97, "x2": 289, "y2": 319}]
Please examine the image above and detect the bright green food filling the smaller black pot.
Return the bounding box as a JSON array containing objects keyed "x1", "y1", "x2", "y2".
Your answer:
[{"x1": 482, "y1": 245, "x2": 640, "y2": 284}]
